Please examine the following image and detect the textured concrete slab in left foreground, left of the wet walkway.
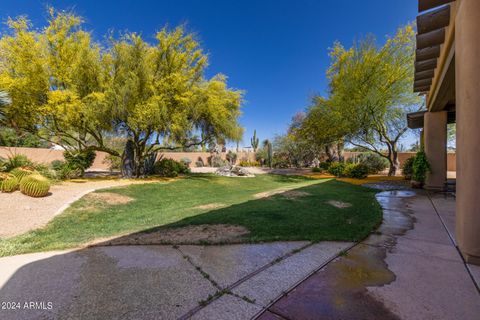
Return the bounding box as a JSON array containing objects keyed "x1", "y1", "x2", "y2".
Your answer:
[{"x1": 0, "y1": 242, "x2": 353, "y2": 320}]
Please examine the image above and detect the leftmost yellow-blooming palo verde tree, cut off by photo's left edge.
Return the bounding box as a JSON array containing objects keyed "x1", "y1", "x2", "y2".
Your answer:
[{"x1": 0, "y1": 9, "x2": 110, "y2": 154}]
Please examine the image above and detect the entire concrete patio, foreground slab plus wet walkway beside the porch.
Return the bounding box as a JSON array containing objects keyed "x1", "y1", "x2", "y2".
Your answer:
[{"x1": 0, "y1": 191, "x2": 480, "y2": 320}]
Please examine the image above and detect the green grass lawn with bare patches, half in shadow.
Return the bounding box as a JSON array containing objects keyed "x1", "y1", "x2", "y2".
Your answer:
[{"x1": 0, "y1": 174, "x2": 382, "y2": 256}]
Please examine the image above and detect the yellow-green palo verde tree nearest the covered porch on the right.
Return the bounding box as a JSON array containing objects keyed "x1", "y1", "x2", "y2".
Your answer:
[{"x1": 327, "y1": 25, "x2": 420, "y2": 175}]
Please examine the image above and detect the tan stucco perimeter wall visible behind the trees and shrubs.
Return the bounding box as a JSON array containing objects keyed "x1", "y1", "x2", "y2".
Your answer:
[{"x1": 0, "y1": 147, "x2": 456, "y2": 171}]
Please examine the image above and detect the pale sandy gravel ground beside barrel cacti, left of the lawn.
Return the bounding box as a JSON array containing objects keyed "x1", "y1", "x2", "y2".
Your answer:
[{"x1": 0, "y1": 179, "x2": 159, "y2": 238}]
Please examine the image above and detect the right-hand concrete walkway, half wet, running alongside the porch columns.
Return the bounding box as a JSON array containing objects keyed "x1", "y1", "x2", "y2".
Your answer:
[{"x1": 258, "y1": 191, "x2": 480, "y2": 320}]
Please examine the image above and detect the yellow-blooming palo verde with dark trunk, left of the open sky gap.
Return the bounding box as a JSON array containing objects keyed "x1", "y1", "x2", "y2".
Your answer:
[{"x1": 105, "y1": 27, "x2": 243, "y2": 176}]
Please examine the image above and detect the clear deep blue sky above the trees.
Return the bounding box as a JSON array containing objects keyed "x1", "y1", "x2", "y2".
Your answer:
[{"x1": 0, "y1": 0, "x2": 417, "y2": 145}]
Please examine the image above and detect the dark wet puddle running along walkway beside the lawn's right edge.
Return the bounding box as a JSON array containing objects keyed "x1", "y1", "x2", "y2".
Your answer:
[{"x1": 259, "y1": 192, "x2": 415, "y2": 320}]
